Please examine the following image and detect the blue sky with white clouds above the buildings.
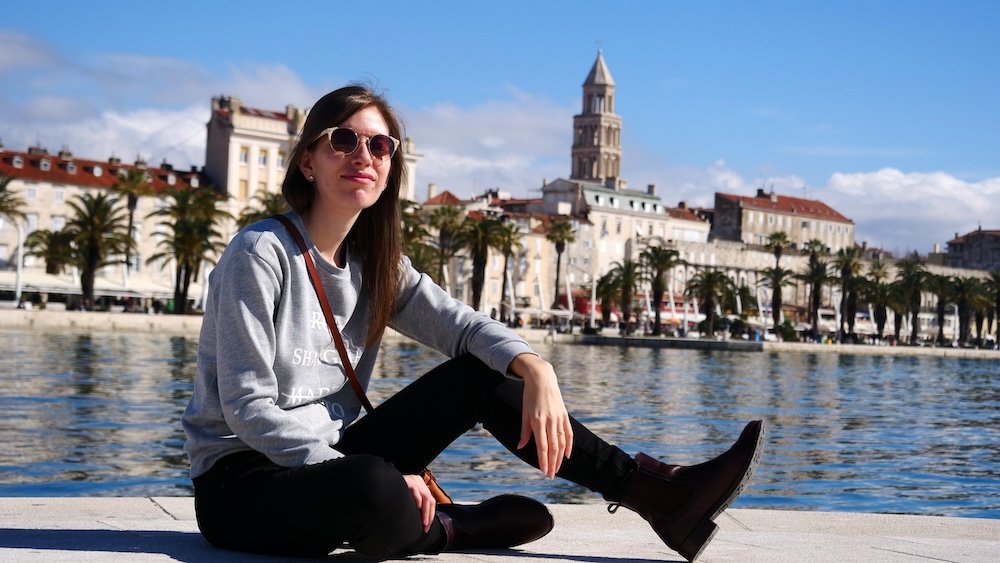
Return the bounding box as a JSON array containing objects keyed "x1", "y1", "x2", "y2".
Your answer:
[{"x1": 0, "y1": 0, "x2": 1000, "y2": 252}]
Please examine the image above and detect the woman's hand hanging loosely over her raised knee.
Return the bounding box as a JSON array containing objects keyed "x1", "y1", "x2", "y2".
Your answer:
[{"x1": 510, "y1": 354, "x2": 573, "y2": 479}]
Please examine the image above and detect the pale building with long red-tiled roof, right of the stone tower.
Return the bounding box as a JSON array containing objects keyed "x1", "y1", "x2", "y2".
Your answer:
[{"x1": 710, "y1": 189, "x2": 854, "y2": 253}]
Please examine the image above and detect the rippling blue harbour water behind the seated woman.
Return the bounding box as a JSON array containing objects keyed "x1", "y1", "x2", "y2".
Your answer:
[{"x1": 0, "y1": 332, "x2": 1000, "y2": 518}]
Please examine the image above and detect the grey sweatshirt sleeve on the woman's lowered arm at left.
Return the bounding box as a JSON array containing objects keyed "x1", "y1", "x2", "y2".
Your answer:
[{"x1": 210, "y1": 237, "x2": 342, "y2": 467}]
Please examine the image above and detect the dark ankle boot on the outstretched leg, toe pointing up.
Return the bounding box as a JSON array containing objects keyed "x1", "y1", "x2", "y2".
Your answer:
[{"x1": 608, "y1": 420, "x2": 764, "y2": 561}]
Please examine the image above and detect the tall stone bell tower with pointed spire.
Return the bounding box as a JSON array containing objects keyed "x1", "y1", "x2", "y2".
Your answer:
[{"x1": 570, "y1": 50, "x2": 622, "y2": 187}]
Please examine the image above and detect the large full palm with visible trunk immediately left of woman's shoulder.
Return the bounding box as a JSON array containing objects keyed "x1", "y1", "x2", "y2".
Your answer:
[{"x1": 146, "y1": 186, "x2": 232, "y2": 315}]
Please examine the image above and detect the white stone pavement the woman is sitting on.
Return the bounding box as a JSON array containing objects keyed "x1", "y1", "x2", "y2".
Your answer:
[{"x1": 0, "y1": 497, "x2": 1000, "y2": 563}]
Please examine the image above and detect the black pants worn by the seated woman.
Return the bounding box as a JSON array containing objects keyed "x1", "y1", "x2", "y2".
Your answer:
[{"x1": 194, "y1": 356, "x2": 635, "y2": 558}]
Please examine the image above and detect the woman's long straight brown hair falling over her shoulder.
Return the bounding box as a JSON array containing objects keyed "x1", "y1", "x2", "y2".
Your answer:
[{"x1": 281, "y1": 85, "x2": 406, "y2": 346}]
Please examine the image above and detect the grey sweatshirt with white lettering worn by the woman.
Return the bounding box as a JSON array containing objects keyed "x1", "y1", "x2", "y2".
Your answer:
[{"x1": 182, "y1": 212, "x2": 531, "y2": 478}]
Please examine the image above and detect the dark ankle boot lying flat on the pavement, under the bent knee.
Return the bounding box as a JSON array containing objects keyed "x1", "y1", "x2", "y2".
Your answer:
[{"x1": 437, "y1": 495, "x2": 554, "y2": 551}]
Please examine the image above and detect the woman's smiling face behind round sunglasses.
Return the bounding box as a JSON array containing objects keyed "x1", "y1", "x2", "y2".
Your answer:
[{"x1": 299, "y1": 106, "x2": 392, "y2": 219}]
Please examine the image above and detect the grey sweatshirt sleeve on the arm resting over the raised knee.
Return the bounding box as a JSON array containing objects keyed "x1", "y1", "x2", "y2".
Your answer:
[{"x1": 389, "y1": 257, "x2": 534, "y2": 373}]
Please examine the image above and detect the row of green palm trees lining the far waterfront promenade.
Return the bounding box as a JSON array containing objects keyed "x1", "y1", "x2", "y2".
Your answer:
[{"x1": 0, "y1": 177, "x2": 1000, "y2": 345}]
